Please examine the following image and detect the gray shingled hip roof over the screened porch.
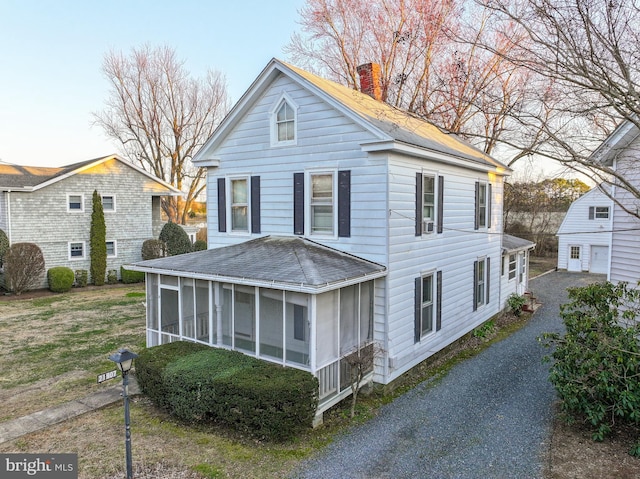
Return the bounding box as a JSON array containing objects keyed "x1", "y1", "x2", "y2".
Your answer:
[{"x1": 126, "y1": 236, "x2": 387, "y2": 294}]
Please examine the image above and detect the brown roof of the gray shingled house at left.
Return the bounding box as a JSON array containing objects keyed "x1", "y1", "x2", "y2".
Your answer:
[{"x1": 0, "y1": 155, "x2": 182, "y2": 196}]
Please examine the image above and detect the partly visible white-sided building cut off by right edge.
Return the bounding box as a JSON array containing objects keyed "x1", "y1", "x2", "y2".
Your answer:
[{"x1": 592, "y1": 120, "x2": 640, "y2": 285}]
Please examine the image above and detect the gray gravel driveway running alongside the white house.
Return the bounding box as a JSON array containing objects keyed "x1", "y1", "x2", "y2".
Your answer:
[{"x1": 291, "y1": 272, "x2": 605, "y2": 479}]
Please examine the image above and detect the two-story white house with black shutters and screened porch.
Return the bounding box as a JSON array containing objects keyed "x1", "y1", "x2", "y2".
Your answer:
[{"x1": 130, "y1": 59, "x2": 533, "y2": 420}]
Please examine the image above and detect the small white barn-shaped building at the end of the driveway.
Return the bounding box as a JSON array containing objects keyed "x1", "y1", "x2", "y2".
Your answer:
[{"x1": 556, "y1": 186, "x2": 613, "y2": 274}]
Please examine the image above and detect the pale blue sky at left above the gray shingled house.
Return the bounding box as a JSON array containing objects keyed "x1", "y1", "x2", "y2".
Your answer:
[{"x1": 0, "y1": 0, "x2": 304, "y2": 166}]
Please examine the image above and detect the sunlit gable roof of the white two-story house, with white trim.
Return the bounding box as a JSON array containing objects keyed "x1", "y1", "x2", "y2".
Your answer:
[{"x1": 194, "y1": 58, "x2": 511, "y2": 174}]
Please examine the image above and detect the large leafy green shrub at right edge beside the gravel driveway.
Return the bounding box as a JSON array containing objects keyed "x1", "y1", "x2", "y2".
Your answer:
[{"x1": 543, "y1": 282, "x2": 640, "y2": 455}]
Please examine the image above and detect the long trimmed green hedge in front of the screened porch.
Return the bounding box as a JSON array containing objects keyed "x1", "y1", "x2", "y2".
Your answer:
[{"x1": 136, "y1": 342, "x2": 318, "y2": 440}]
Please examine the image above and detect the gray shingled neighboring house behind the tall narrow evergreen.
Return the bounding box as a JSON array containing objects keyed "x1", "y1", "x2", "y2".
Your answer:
[{"x1": 0, "y1": 155, "x2": 181, "y2": 287}]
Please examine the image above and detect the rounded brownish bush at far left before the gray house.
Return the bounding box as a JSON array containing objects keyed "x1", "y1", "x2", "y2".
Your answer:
[{"x1": 4, "y1": 243, "x2": 45, "y2": 294}]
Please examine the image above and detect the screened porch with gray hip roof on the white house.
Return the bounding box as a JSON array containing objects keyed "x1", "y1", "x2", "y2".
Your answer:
[{"x1": 127, "y1": 236, "x2": 386, "y2": 414}]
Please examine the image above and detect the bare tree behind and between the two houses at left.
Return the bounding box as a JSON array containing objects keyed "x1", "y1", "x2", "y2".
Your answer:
[{"x1": 94, "y1": 46, "x2": 229, "y2": 224}]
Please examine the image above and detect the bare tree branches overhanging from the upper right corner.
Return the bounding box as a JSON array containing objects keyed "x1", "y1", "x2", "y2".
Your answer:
[{"x1": 476, "y1": 0, "x2": 640, "y2": 216}]
